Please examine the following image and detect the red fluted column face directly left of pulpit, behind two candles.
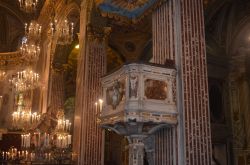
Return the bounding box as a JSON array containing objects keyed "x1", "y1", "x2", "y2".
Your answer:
[{"x1": 79, "y1": 27, "x2": 106, "y2": 165}]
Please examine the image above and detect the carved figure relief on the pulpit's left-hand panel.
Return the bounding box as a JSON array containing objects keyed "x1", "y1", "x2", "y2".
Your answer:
[{"x1": 106, "y1": 81, "x2": 125, "y2": 109}]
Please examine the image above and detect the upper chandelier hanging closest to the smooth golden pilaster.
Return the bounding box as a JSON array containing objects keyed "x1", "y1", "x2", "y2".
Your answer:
[{"x1": 50, "y1": 19, "x2": 74, "y2": 45}]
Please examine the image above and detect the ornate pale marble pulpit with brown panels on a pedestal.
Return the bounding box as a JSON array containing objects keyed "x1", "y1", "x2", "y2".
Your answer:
[{"x1": 99, "y1": 63, "x2": 178, "y2": 165}]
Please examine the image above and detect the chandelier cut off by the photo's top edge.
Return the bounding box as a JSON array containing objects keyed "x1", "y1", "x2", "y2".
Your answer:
[{"x1": 19, "y1": 0, "x2": 38, "y2": 13}]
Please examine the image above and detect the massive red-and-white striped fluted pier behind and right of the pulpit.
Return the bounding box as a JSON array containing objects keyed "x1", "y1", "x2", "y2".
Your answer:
[{"x1": 152, "y1": 0, "x2": 211, "y2": 165}]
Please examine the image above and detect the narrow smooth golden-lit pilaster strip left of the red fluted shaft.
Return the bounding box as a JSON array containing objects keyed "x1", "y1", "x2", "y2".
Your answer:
[{"x1": 73, "y1": 0, "x2": 91, "y2": 160}]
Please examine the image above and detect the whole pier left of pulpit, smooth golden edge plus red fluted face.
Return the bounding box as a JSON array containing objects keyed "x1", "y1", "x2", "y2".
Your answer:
[{"x1": 73, "y1": 1, "x2": 106, "y2": 162}]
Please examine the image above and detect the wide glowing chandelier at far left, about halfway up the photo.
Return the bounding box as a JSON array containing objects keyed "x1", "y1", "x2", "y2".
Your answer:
[{"x1": 9, "y1": 68, "x2": 39, "y2": 92}]
